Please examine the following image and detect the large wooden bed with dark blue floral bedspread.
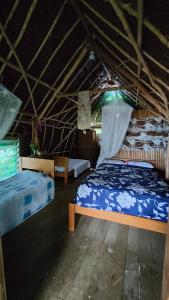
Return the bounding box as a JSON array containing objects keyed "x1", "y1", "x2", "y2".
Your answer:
[{"x1": 69, "y1": 162, "x2": 169, "y2": 233}]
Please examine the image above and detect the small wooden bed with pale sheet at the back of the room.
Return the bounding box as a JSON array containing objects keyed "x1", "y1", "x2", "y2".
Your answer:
[{"x1": 54, "y1": 156, "x2": 90, "y2": 187}]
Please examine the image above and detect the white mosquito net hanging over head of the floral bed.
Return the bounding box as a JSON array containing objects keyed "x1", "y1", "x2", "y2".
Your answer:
[{"x1": 97, "y1": 99, "x2": 133, "y2": 166}]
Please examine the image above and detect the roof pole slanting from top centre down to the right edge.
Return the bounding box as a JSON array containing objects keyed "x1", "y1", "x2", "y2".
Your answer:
[{"x1": 80, "y1": 0, "x2": 169, "y2": 73}]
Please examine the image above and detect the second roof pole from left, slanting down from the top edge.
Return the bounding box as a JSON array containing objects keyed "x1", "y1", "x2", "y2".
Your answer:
[{"x1": 13, "y1": 0, "x2": 68, "y2": 92}]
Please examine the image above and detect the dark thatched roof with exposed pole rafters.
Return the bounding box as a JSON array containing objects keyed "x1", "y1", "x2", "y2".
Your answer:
[{"x1": 0, "y1": 0, "x2": 169, "y2": 151}]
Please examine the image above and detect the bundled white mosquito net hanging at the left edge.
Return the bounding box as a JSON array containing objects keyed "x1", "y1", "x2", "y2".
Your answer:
[{"x1": 0, "y1": 84, "x2": 22, "y2": 140}]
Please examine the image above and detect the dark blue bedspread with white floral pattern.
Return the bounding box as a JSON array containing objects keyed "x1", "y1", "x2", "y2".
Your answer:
[{"x1": 75, "y1": 163, "x2": 169, "y2": 222}]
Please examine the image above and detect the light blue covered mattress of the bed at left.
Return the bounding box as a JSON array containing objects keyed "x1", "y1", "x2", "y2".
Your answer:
[{"x1": 0, "y1": 171, "x2": 55, "y2": 235}]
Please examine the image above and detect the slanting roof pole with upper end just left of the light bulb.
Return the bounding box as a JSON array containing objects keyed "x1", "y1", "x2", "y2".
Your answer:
[{"x1": 40, "y1": 48, "x2": 87, "y2": 118}]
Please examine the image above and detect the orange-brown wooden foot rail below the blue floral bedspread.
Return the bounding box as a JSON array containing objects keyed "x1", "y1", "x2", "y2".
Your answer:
[{"x1": 74, "y1": 204, "x2": 167, "y2": 234}]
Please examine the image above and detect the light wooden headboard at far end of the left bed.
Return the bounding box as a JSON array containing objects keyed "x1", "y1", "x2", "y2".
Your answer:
[{"x1": 20, "y1": 157, "x2": 55, "y2": 178}]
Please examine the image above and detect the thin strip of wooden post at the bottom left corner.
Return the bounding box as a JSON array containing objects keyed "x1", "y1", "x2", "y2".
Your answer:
[{"x1": 0, "y1": 237, "x2": 7, "y2": 300}]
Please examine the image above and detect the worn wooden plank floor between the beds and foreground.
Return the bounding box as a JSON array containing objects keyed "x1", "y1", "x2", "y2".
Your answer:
[{"x1": 3, "y1": 172, "x2": 164, "y2": 300}]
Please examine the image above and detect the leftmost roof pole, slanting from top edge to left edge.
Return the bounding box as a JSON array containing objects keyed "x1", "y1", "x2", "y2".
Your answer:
[{"x1": 0, "y1": 0, "x2": 38, "y2": 76}]
